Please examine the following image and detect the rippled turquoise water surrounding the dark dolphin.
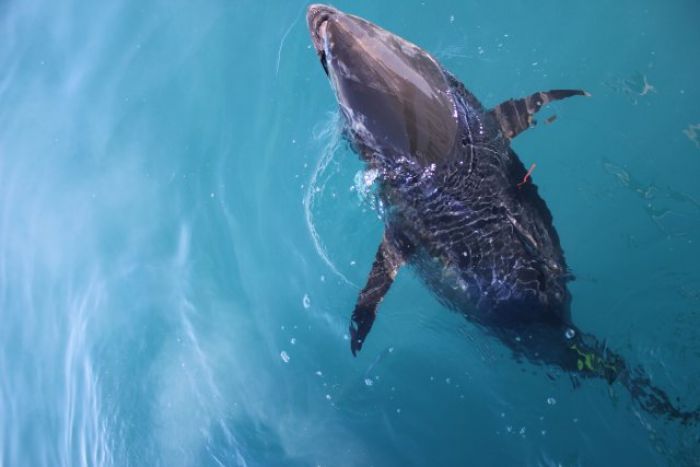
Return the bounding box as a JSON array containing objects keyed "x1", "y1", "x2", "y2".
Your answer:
[{"x1": 0, "y1": 0, "x2": 700, "y2": 467}]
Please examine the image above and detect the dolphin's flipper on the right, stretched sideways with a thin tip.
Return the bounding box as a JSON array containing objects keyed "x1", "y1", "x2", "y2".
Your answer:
[{"x1": 489, "y1": 89, "x2": 590, "y2": 139}]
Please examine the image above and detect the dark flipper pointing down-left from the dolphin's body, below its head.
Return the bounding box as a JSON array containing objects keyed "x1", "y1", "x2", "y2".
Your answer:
[{"x1": 350, "y1": 235, "x2": 404, "y2": 355}]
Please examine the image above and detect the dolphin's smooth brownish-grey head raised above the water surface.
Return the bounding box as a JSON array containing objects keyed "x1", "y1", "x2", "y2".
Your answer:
[{"x1": 307, "y1": 4, "x2": 459, "y2": 163}]
